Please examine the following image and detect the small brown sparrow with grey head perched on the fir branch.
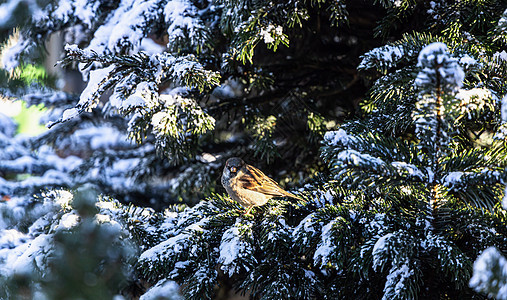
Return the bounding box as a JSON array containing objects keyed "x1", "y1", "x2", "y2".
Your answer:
[{"x1": 222, "y1": 157, "x2": 299, "y2": 215}]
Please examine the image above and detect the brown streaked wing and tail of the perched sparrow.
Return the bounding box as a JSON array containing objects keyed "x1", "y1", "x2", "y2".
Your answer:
[{"x1": 240, "y1": 165, "x2": 297, "y2": 198}]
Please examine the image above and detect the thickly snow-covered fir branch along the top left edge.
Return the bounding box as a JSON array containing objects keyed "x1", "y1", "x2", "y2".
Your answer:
[{"x1": 4, "y1": 0, "x2": 212, "y2": 68}]
